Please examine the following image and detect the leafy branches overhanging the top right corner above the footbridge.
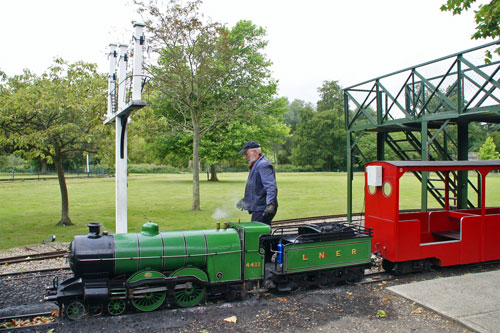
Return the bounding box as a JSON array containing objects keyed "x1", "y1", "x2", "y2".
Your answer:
[{"x1": 441, "y1": 0, "x2": 500, "y2": 63}]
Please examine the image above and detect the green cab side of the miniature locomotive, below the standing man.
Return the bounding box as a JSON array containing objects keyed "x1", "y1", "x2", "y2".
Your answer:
[{"x1": 229, "y1": 222, "x2": 271, "y2": 280}]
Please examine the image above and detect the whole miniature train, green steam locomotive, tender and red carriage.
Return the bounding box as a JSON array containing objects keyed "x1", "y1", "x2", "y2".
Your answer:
[{"x1": 45, "y1": 161, "x2": 500, "y2": 319}]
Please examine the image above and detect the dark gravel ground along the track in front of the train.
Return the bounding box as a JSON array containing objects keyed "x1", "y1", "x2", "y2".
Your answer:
[{"x1": 0, "y1": 243, "x2": 494, "y2": 333}]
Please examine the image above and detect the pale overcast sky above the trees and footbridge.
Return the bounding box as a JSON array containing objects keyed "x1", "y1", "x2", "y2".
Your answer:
[{"x1": 0, "y1": 0, "x2": 484, "y2": 105}]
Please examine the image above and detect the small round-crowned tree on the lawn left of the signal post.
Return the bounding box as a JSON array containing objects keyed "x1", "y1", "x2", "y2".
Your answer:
[{"x1": 0, "y1": 59, "x2": 106, "y2": 225}]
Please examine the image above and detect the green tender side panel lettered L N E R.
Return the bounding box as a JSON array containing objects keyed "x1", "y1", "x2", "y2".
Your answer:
[{"x1": 283, "y1": 237, "x2": 371, "y2": 273}]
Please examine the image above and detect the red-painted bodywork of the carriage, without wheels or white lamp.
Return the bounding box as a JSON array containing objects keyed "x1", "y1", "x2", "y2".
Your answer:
[{"x1": 365, "y1": 161, "x2": 500, "y2": 266}]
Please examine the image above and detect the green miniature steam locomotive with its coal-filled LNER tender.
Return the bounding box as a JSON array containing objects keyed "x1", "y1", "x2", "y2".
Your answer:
[{"x1": 45, "y1": 222, "x2": 372, "y2": 319}]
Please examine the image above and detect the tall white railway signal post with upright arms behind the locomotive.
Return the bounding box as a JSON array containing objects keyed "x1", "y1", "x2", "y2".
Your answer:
[{"x1": 105, "y1": 23, "x2": 146, "y2": 234}]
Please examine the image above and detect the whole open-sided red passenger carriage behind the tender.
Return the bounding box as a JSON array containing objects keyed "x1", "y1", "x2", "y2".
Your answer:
[{"x1": 365, "y1": 161, "x2": 500, "y2": 273}]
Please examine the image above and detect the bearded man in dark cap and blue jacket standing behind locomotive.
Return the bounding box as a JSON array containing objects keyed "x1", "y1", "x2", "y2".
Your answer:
[{"x1": 236, "y1": 141, "x2": 278, "y2": 225}]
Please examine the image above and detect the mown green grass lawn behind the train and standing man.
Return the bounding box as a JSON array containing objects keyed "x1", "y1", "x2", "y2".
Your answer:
[{"x1": 0, "y1": 173, "x2": 500, "y2": 249}]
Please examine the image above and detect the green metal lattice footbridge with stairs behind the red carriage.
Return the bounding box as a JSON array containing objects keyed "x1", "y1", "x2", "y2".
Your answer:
[{"x1": 344, "y1": 41, "x2": 500, "y2": 220}]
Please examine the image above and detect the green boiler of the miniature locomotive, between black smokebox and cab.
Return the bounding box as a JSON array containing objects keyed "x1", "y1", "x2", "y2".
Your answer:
[{"x1": 115, "y1": 222, "x2": 243, "y2": 282}]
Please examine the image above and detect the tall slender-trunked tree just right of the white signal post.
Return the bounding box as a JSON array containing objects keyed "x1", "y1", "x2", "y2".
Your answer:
[{"x1": 136, "y1": 0, "x2": 277, "y2": 211}]
